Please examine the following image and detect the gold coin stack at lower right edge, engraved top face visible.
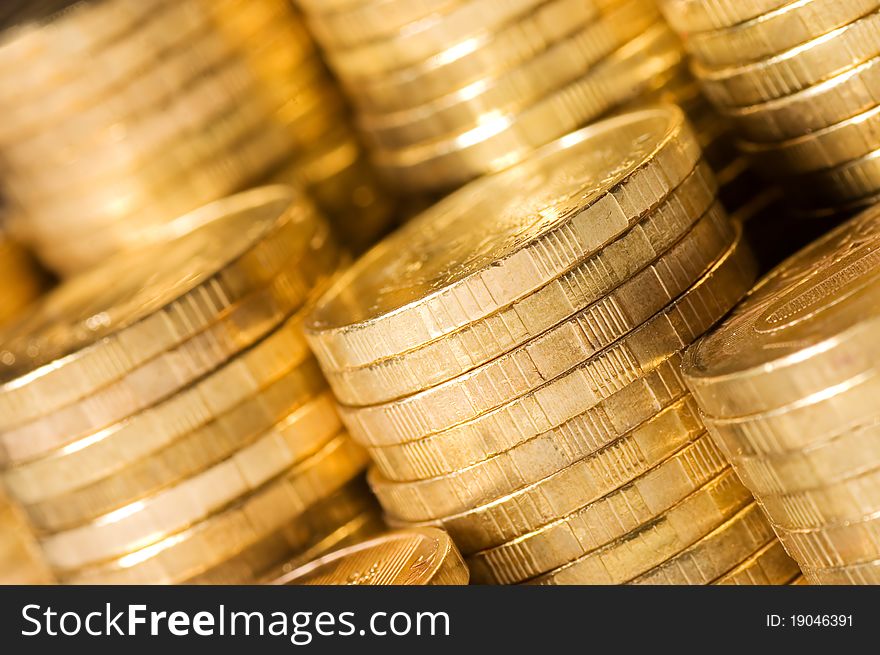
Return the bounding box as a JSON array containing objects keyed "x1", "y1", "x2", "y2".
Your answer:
[{"x1": 684, "y1": 207, "x2": 880, "y2": 584}]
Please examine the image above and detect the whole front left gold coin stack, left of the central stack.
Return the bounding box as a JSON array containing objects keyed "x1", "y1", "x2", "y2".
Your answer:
[{"x1": 0, "y1": 186, "x2": 379, "y2": 583}]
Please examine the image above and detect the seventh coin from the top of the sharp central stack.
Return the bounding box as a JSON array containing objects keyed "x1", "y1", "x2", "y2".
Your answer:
[{"x1": 467, "y1": 435, "x2": 727, "y2": 584}]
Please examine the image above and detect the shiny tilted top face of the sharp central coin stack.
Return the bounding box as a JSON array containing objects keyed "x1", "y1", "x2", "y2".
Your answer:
[{"x1": 312, "y1": 111, "x2": 678, "y2": 336}]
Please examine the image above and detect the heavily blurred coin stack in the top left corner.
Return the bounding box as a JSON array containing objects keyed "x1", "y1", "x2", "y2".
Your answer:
[{"x1": 0, "y1": 0, "x2": 390, "y2": 274}]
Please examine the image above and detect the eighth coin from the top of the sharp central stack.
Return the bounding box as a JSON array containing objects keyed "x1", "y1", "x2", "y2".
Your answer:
[{"x1": 527, "y1": 470, "x2": 752, "y2": 585}]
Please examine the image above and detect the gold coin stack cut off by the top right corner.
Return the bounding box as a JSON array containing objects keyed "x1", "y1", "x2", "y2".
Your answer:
[{"x1": 660, "y1": 0, "x2": 880, "y2": 215}]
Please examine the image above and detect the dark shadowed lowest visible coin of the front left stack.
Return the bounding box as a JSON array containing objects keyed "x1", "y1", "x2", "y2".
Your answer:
[{"x1": 186, "y1": 479, "x2": 382, "y2": 584}]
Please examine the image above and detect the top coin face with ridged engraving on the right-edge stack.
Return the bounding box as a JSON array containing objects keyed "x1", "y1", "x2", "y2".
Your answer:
[{"x1": 688, "y1": 208, "x2": 880, "y2": 379}]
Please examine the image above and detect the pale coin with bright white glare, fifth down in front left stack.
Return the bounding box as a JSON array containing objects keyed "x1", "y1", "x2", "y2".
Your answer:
[{"x1": 46, "y1": 432, "x2": 363, "y2": 571}]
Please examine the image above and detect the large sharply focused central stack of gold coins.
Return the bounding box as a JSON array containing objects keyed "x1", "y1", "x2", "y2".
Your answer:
[{"x1": 306, "y1": 106, "x2": 798, "y2": 583}]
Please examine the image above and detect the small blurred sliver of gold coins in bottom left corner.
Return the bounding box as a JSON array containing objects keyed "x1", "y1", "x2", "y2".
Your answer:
[{"x1": 0, "y1": 493, "x2": 52, "y2": 585}]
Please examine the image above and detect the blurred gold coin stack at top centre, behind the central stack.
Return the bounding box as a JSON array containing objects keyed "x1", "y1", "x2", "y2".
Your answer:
[{"x1": 299, "y1": 0, "x2": 696, "y2": 191}]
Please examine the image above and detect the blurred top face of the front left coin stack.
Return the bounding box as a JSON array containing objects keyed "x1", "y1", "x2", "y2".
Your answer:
[{"x1": 0, "y1": 187, "x2": 294, "y2": 384}]
